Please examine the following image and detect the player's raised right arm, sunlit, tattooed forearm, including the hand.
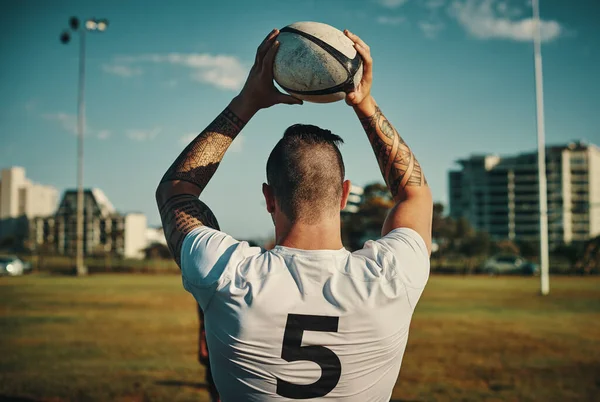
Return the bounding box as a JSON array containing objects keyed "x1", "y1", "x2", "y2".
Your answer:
[{"x1": 345, "y1": 31, "x2": 433, "y2": 252}]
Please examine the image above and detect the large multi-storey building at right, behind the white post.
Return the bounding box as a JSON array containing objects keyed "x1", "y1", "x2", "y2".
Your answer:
[{"x1": 449, "y1": 143, "x2": 600, "y2": 246}]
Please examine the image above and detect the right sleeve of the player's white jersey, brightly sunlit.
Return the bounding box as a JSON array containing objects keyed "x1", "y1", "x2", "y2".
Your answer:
[{"x1": 358, "y1": 228, "x2": 430, "y2": 308}]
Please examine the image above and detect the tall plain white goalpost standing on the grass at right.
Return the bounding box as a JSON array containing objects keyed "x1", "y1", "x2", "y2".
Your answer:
[{"x1": 532, "y1": 0, "x2": 550, "y2": 295}]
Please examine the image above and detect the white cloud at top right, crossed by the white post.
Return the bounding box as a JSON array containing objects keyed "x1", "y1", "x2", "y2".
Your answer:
[{"x1": 450, "y1": 0, "x2": 564, "y2": 42}]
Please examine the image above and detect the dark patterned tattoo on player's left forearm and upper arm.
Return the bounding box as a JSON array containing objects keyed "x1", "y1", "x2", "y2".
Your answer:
[{"x1": 157, "y1": 108, "x2": 245, "y2": 265}]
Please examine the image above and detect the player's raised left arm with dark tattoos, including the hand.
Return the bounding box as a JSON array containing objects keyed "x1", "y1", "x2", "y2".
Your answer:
[{"x1": 156, "y1": 29, "x2": 302, "y2": 265}]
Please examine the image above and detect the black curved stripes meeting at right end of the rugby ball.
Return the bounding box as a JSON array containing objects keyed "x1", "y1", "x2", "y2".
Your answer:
[{"x1": 279, "y1": 26, "x2": 362, "y2": 95}]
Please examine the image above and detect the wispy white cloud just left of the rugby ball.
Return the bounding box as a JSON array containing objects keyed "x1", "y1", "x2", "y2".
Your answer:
[{"x1": 116, "y1": 53, "x2": 249, "y2": 91}]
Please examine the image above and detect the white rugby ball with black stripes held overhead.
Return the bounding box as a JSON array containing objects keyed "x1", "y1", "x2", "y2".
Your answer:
[{"x1": 273, "y1": 21, "x2": 363, "y2": 103}]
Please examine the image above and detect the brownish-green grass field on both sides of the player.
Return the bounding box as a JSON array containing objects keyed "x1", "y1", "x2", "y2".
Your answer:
[{"x1": 0, "y1": 274, "x2": 600, "y2": 402}]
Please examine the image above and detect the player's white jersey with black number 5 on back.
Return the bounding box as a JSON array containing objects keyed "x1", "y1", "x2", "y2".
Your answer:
[{"x1": 181, "y1": 227, "x2": 429, "y2": 402}]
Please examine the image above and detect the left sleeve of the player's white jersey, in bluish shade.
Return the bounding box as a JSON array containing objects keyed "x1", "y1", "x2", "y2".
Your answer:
[{"x1": 181, "y1": 226, "x2": 261, "y2": 310}]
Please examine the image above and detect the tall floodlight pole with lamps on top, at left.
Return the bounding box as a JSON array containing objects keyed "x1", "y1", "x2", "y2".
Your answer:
[{"x1": 60, "y1": 17, "x2": 108, "y2": 275}]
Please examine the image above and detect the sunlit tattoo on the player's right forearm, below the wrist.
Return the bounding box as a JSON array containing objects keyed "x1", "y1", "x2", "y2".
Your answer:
[{"x1": 360, "y1": 107, "x2": 427, "y2": 200}]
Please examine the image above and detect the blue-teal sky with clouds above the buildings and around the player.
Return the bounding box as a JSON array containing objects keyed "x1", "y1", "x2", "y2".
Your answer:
[{"x1": 0, "y1": 0, "x2": 600, "y2": 238}]
